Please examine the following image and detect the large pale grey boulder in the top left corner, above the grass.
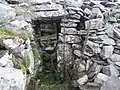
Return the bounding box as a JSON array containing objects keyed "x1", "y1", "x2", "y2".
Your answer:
[{"x1": 0, "y1": 3, "x2": 16, "y2": 21}]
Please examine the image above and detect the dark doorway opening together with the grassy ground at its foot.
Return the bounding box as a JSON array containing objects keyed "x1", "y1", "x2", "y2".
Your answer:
[{"x1": 31, "y1": 20, "x2": 79, "y2": 90}]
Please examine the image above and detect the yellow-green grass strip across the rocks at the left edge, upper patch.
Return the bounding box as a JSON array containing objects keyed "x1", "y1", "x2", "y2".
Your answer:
[{"x1": 0, "y1": 28, "x2": 28, "y2": 39}]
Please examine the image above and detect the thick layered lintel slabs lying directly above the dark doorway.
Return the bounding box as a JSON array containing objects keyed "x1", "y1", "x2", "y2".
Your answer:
[{"x1": 31, "y1": 0, "x2": 67, "y2": 20}]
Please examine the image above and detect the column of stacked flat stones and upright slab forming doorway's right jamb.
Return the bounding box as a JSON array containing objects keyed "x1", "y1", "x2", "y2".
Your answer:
[{"x1": 58, "y1": 3, "x2": 82, "y2": 67}]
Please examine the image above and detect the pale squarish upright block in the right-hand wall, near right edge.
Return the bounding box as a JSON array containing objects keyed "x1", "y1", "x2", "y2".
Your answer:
[{"x1": 100, "y1": 45, "x2": 114, "y2": 59}]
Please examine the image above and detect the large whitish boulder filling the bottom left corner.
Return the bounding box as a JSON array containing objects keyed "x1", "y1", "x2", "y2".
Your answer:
[{"x1": 0, "y1": 67, "x2": 26, "y2": 90}]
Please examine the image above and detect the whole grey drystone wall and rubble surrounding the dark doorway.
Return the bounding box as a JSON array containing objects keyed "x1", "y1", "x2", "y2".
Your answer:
[{"x1": 0, "y1": 0, "x2": 120, "y2": 90}]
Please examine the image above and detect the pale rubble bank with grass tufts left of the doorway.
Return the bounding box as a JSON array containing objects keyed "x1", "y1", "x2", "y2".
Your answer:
[{"x1": 0, "y1": 0, "x2": 38, "y2": 90}]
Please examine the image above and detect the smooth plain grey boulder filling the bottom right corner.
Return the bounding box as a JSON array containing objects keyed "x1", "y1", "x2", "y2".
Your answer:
[{"x1": 101, "y1": 76, "x2": 120, "y2": 90}]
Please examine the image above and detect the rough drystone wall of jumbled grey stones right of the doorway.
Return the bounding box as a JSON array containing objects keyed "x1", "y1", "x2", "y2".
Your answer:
[{"x1": 31, "y1": 0, "x2": 120, "y2": 90}]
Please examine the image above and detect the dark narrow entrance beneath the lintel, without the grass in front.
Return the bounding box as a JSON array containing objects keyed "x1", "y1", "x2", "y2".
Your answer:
[{"x1": 33, "y1": 20, "x2": 61, "y2": 82}]
